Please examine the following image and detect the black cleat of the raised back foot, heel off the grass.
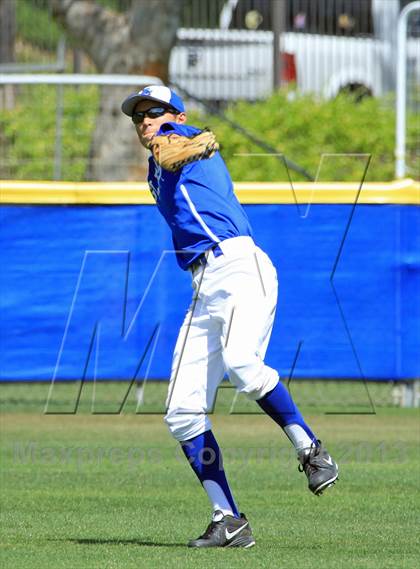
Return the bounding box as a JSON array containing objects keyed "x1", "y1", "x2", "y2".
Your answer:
[{"x1": 298, "y1": 441, "x2": 338, "y2": 496}]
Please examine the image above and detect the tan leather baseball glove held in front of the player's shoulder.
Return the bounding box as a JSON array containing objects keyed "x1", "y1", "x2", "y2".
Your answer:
[{"x1": 150, "y1": 129, "x2": 219, "y2": 172}]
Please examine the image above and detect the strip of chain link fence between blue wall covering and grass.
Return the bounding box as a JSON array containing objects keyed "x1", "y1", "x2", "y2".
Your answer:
[{"x1": 0, "y1": 379, "x2": 420, "y2": 415}]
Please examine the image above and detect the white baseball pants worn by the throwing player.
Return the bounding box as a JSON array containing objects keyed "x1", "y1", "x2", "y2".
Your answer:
[{"x1": 165, "y1": 237, "x2": 279, "y2": 441}]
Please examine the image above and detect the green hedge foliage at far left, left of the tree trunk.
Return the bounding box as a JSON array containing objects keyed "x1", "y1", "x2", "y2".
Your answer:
[{"x1": 0, "y1": 85, "x2": 99, "y2": 181}]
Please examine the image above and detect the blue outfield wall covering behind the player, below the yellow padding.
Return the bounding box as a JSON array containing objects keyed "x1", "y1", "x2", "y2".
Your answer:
[{"x1": 0, "y1": 204, "x2": 420, "y2": 381}]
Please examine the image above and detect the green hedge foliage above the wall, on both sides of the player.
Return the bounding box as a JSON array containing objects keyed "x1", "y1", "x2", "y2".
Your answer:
[{"x1": 0, "y1": 86, "x2": 420, "y2": 181}]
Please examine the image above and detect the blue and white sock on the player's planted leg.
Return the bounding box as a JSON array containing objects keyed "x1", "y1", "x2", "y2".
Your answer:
[{"x1": 181, "y1": 431, "x2": 239, "y2": 518}]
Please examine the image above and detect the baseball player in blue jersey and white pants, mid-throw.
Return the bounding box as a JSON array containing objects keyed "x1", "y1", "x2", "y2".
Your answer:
[{"x1": 122, "y1": 86, "x2": 338, "y2": 548}]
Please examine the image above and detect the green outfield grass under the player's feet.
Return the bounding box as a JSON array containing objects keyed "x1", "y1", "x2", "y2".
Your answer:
[{"x1": 0, "y1": 386, "x2": 420, "y2": 569}]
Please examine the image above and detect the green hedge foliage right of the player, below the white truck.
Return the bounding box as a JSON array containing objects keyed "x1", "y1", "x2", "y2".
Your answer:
[{"x1": 194, "y1": 91, "x2": 420, "y2": 181}]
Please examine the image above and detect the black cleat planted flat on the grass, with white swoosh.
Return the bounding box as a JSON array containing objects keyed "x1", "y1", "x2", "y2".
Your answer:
[{"x1": 188, "y1": 510, "x2": 255, "y2": 549}]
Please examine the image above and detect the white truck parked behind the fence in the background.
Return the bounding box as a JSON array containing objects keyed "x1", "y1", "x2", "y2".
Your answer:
[{"x1": 169, "y1": 0, "x2": 420, "y2": 101}]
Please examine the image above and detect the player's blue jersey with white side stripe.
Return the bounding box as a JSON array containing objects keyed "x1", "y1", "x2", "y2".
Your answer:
[{"x1": 147, "y1": 122, "x2": 252, "y2": 270}]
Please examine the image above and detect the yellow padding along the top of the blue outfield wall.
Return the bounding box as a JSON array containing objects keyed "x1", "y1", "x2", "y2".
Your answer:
[{"x1": 0, "y1": 179, "x2": 420, "y2": 205}]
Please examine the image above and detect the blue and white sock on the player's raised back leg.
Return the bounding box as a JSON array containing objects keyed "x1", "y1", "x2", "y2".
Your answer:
[{"x1": 257, "y1": 381, "x2": 318, "y2": 446}]
